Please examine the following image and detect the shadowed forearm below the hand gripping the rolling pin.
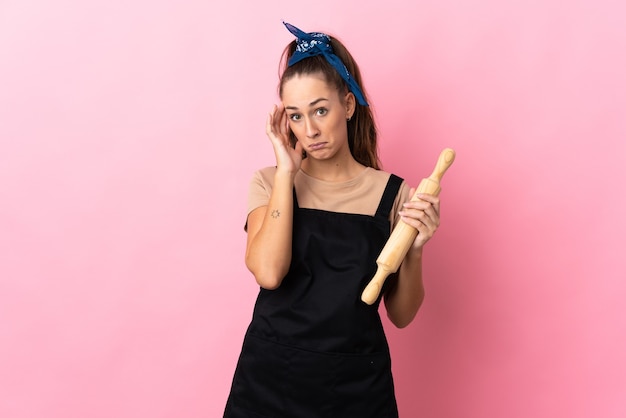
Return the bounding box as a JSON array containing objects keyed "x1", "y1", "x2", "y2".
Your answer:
[{"x1": 385, "y1": 248, "x2": 424, "y2": 328}]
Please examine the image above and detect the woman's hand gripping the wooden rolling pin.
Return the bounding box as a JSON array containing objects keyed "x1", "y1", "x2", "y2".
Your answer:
[{"x1": 399, "y1": 188, "x2": 439, "y2": 249}]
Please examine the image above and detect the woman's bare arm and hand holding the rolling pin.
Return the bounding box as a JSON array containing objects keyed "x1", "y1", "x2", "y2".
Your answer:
[{"x1": 384, "y1": 189, "x2": 439, "y2": 328}]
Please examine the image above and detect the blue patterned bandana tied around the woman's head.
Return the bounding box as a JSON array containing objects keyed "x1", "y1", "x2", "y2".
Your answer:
[{"x1": 283, "y1": 22, "x2": 368, "y2": 106}]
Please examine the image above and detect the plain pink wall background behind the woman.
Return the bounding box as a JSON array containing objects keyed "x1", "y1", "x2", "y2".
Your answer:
[{"x1": 0, "y1": 0, "x2": 626, "y2": 418}]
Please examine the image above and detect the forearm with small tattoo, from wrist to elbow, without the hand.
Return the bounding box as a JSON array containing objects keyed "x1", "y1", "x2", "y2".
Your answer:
[{"x1": 246, "y1": 171, "x2": 293, "y2": 289}]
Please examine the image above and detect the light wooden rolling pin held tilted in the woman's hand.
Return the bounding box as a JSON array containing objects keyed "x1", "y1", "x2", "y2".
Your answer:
[{"x1": 361, "y1": 148, "x2": 456, "y2": 305}]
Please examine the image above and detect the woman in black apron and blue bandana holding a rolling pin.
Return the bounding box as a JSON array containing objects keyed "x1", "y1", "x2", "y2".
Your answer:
[{"x1": 224, "y1": 24, "x2": 439, "y2": 418}]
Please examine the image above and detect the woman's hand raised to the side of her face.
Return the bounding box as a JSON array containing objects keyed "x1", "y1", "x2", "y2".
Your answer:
[{"x1": 265, "y1": 104, "x2": 302, "y2": 175}]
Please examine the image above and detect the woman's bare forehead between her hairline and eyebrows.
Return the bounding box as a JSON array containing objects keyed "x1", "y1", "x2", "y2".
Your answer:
[{"x1": 282, "y1": 74, "x2": 339, "y2": 107}]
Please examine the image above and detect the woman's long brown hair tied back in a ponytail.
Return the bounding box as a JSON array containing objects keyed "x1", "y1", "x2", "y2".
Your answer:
[{"x1": 278, "y1": 36, "x2": 381, "y2": 170}]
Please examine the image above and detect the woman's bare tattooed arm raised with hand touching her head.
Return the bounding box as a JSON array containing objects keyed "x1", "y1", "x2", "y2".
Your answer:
[{"x1": 246, "y1": 106, "x2": 302, "y2": 289}]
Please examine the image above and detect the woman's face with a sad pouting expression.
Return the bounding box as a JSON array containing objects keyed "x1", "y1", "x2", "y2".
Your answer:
[{"x1": 282, "y1": 74, "x2": 354, "y2": 159}]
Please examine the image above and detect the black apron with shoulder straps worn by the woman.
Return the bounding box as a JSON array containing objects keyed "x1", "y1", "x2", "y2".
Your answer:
[{"x1": 224, "y1": 175, "x2": 402, "y2": 418}]
